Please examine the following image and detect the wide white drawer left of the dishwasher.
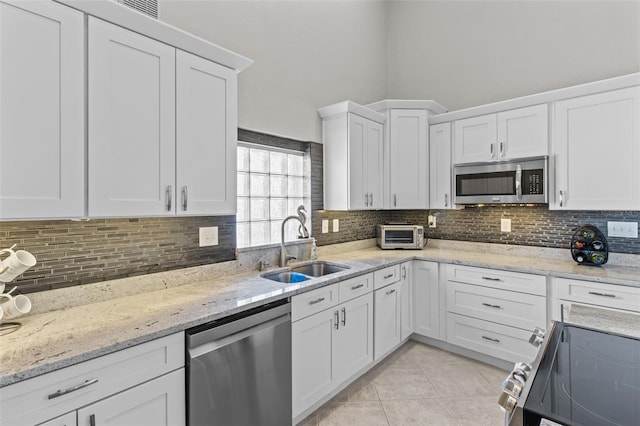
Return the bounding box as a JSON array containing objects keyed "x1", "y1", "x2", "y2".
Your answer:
[{"x1": 0, "y1": 333, "x2": 184, "y2": 425}]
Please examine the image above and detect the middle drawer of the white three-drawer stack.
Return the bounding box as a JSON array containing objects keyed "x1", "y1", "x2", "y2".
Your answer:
[{"x1": 447, "y1": 282, "x2": 547, "y2": 331}]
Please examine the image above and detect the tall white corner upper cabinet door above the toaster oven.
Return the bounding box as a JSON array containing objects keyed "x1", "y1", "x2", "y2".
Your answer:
[{"x1": 388, "y1": 109, "x2": 429, "y2": 209}]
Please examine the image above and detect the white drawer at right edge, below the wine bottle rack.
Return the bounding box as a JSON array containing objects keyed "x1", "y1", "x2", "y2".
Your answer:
[{"x1": 551, "y1": 278, "x2": 640, "y2": 312}]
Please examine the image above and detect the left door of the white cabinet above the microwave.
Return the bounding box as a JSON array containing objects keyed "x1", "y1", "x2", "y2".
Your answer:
[{"x1": 454, "y1": 114, "x2": 498, "y2": 164}]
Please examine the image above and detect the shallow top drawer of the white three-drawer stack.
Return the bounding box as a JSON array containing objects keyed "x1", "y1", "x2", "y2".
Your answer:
[{"x1": 447, "y1": 264, "x2": 547, "y2": 296}]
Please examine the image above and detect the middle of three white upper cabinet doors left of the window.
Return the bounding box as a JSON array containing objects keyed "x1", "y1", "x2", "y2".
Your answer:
[{"x1": 88, "y1": 17, "x2": 176, "y2": 217}]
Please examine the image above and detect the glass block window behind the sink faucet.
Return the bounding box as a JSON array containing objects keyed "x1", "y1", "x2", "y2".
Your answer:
[{"x1": 236, "y1": 142, "x2": 311, "y2": 247}]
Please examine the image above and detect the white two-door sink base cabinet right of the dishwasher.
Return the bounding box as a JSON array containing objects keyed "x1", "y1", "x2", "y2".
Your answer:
[{"x1": 291, "y1": 274, "x2": 373, "y2": 418}]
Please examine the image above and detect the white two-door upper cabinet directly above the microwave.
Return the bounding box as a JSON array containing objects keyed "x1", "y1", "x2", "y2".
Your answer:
[{"x1": 454, "y1": 104, "x2": 549, "y2": 164}]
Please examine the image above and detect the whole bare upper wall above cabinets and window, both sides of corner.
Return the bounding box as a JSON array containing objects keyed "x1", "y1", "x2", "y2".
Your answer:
[{"x1": 160, "y1": 0, "x2": 640, "y2": 142}]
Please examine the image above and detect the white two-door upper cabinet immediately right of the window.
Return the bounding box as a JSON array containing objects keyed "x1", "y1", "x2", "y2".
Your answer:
[{"x1": 318, "y1": 101, "x2": 385, "y2": 210}]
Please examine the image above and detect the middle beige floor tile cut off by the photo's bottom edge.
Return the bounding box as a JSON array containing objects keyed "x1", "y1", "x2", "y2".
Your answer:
[{"x1": 382, "y1": 399, "x2": 458, "y2": 426}]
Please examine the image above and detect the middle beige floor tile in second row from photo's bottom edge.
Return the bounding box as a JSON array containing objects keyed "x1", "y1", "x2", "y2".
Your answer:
[{"x1": 373, "y1": 368, "x2": 439, "y2": 400}]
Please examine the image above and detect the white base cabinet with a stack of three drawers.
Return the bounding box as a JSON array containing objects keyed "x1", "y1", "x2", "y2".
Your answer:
[{"x1": 445, "y1": 265, "x2": 547, "y2": 362}]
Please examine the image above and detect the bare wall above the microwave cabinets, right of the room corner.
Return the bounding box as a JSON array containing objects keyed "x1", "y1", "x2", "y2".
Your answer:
[{"x1": 388, "y1": 0, "x2": 640, "y2": 110}]
